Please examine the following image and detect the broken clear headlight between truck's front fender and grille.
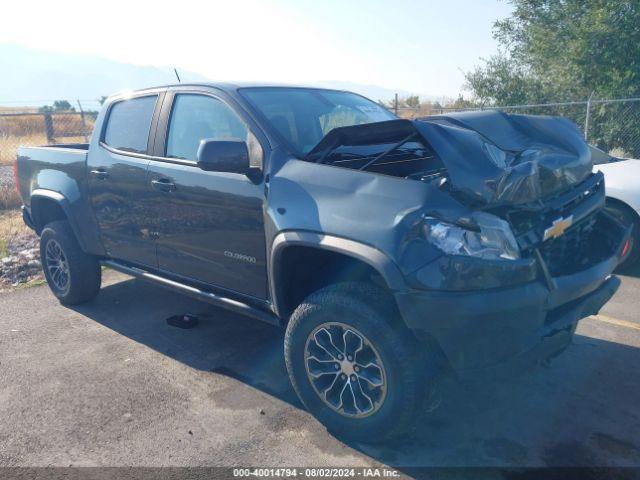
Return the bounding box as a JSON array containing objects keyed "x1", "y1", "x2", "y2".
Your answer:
[{"x1": 423, "y1": 212, "x2": 520, "y2": 260}]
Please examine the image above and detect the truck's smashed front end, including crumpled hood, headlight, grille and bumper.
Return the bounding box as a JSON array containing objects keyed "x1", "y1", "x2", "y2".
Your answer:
[{"x1": 308, "y1": 111, "x2": 630, "y2": 373}]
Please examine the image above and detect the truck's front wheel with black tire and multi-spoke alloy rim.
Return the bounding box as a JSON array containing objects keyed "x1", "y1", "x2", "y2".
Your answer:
[{"x1": 285, "y1": 282, "x2": 438, "y2": 443}]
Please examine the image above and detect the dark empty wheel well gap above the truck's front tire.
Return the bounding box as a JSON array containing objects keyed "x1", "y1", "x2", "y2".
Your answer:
[{"x1": 276, "y1": 246, "x2": 388, "y2": 318}]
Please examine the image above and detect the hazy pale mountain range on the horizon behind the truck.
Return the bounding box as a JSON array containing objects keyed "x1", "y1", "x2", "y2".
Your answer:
[{"x1": 0, "y1": 44, "x2": 434, "y2": 106}]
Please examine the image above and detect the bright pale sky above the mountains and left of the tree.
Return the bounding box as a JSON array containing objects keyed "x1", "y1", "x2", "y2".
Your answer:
[{"x1": 0, "y1": 0, "x2": 511, "y2": 96}]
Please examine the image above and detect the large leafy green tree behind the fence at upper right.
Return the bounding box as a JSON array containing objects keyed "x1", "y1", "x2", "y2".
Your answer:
[{"x1": 466, "y1": 0, "x2": 640, "y2": 155}]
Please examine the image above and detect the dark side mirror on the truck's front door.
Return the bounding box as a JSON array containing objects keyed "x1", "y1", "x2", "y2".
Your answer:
[{"x1": 198, "y1": 139, "x2": 250, "y2": 175}]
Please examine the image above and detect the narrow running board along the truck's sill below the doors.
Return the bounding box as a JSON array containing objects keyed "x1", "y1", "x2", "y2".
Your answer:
[{"x1": 102, "y1": 260, "x2": 282, "y2": 326}]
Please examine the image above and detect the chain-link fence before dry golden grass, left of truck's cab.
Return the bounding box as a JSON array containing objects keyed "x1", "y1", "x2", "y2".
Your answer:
[{"x1": 0, "y1": 103, "x2": 98, "y2": 166}]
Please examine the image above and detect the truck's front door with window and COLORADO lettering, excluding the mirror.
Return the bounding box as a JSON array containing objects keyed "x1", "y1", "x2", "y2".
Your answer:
[{"x1": 149, "y1": 93, "x2": 267, "y2": 299}]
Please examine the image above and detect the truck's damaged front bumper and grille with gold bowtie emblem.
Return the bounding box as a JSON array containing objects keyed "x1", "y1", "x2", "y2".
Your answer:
[{"x1": 396, "y1": 174, "x2": 630, "y2": 375}]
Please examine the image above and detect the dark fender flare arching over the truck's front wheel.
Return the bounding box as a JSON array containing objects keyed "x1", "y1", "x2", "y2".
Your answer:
[{"x1": 269, "y1": 230, "x2": 406, "y2": 318}]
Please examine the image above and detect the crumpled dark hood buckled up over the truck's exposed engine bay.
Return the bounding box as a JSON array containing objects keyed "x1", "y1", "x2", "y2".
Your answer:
[{"x1": 307, "y1": 110, "x2": 593, "y2": 207}]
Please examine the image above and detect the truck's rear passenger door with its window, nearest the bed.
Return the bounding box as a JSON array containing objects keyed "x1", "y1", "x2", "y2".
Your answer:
[{"x1": 87, "y1": 93, "x2": 164, "y2": 268}]
